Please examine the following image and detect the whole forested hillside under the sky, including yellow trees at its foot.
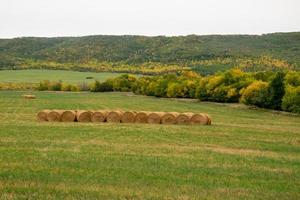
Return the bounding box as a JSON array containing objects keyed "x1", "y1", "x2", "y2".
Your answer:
[{"x1": 0, "y1": 32, "x2": 300, "y2": 74}]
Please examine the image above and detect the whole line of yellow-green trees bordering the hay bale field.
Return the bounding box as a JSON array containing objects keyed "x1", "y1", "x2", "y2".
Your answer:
[{"x1": 32, "y1": 69, "x2": 300, "y2": 113}]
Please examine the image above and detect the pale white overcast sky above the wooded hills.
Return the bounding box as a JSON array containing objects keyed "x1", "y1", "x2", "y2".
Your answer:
[{"x1": 0, "y1": 0, "x2": 300, "y2": 38}]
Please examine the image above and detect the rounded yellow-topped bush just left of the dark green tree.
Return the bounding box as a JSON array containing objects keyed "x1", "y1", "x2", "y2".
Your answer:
[{"x1": 241, "y1": 81, "x2": 269, "y2": 108}]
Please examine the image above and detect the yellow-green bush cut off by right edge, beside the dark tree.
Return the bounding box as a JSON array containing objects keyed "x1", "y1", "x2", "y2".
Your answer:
[{"x1": 282, "y1": 86, "x2": 300, "y2": 113}]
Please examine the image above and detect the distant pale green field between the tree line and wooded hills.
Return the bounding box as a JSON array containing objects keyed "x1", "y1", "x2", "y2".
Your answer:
[{"x1": 0, "y1": 69, "x2": 124, "y2": 83}]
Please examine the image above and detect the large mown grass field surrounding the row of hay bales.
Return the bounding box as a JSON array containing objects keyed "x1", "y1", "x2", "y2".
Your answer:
[{"x1": 0, "y1": 91, "x2": 300, "y2": 200}]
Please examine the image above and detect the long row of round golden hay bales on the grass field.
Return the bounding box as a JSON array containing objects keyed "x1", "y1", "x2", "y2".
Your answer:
[{"x1": 37, "y1": 110, "x2": 211, "y2": 125}]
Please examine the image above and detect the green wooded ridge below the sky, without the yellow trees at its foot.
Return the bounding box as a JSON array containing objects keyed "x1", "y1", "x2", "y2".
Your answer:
[{"x1": 0, "y1": 32, "x2": 300, "y2": 74}]
